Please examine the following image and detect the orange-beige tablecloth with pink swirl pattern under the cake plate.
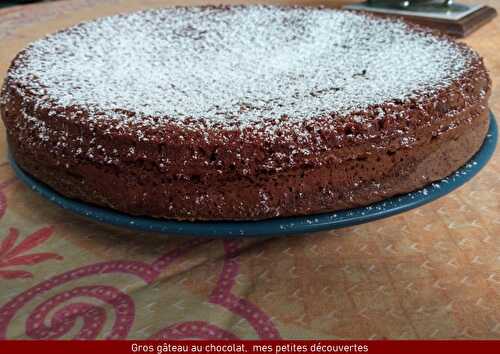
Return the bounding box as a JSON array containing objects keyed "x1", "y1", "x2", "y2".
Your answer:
[{"x1": 0, "y1": 0, "x2": 500, "y2": 339}]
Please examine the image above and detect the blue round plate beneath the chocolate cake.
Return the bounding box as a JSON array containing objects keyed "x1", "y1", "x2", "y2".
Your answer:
[{"x1": 10, "y1": 112, "x2": 498, "y2": 237}]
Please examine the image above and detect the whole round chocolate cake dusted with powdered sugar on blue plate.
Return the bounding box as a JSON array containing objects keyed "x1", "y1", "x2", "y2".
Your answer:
[{"x1": 0, "y1": 6, "x2": 491, "y2": 220}]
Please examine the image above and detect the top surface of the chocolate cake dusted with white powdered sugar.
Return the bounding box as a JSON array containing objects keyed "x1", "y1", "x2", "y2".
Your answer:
[{"x1": 9, "y1": 6, "x2": 475, "y2": 132}]
